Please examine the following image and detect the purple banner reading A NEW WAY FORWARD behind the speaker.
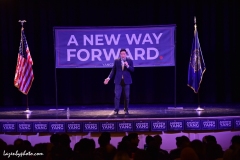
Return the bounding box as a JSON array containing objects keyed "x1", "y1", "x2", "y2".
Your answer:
[{"x1": 54, "y1": 25, "x2": 175, "y2": 68}]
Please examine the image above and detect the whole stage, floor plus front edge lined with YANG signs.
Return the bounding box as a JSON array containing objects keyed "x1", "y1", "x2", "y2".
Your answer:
[{"x1": 0, "y1": 104, "x2": 240, "y2": 133}]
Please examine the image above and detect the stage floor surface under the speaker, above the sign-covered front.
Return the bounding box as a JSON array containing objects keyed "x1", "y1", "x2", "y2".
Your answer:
[{"x1": 0, "y1": 104, "x2": 240, "y2": 121}]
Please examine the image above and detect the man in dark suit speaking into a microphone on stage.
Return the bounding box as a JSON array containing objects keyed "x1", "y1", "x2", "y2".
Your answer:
[{"x1": 104, "y1": 49, "x2": 134, "y2": 115}]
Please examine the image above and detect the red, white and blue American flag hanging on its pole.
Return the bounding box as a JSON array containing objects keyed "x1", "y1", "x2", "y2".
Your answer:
[{"x1": 14, "y1": 28, "x2": 34, "y2": 95}]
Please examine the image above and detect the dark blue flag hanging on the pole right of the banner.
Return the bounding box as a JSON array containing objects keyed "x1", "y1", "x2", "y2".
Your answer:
[{"x1": 188, "y1": 25, "x2": 206, "y2": 93}]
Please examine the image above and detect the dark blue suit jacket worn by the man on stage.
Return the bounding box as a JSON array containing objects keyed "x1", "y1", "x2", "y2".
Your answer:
[{"x1": 108, "y1": 58, "x2": 134, "y2": 84}]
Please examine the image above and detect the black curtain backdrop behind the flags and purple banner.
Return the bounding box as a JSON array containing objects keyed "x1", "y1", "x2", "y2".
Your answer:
[{"x1": 0, "y1": 0, "x2": 240, "y2": 106}]
